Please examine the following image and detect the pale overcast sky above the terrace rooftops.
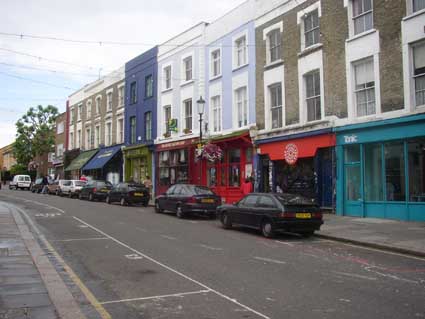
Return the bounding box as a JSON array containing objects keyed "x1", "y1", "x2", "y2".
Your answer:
[{"x1": 0, "y1": 0, "x2": 244, "y2": 147}]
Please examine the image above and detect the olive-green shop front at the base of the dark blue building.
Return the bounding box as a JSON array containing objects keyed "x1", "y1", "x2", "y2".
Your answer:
[{"x1": 123, "y1": 145, "x2": 154, "y2": 183}]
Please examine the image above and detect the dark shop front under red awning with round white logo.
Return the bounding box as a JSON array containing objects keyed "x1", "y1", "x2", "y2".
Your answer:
[{"x1": 256, "y1": 129, "x2": 335, "y2": 209}]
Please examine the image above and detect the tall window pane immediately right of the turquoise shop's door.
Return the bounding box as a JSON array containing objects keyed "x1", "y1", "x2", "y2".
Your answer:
[{"x1": 364, "y1": 144, "x2": 384, "y2": 201}]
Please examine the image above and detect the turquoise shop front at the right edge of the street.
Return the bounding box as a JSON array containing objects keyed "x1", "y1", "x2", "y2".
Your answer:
[{"x1": 335, "y1": 114, "x2": 425, "y2": 221}]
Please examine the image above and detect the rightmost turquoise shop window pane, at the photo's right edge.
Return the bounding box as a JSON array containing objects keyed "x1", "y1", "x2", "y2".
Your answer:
[{"x1": 408, "y1": 138, "x2": 425, "y2": 202}]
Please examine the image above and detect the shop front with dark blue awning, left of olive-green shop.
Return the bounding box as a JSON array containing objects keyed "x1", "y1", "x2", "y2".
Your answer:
[{"x1": 82, "y1": 145, "x2": 123, "y2": 185}]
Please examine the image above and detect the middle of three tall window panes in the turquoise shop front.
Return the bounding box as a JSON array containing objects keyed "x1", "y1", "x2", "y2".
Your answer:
[{"x1": 384, "y1": 142, "x2": 406, "y2": 201}]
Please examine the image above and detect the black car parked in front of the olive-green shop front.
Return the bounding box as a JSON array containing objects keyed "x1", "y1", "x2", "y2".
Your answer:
[{"x1": 106, "y1": 183, "x2": 150, "y2": 207}]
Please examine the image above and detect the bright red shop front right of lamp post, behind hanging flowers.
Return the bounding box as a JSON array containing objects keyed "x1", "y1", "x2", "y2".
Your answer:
[{"x1": 202, "y1": 131, "x2": 253, "y2": 203}]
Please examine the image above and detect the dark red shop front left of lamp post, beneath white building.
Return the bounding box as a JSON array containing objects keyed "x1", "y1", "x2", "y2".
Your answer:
[{"x1": 155, "y1": 138, "x2": 200, "y2": 195}]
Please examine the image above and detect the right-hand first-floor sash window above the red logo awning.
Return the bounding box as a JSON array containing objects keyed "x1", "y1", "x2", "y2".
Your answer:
[{"x1": 304, "y1": 70, "x2": 322, "y2": 122}]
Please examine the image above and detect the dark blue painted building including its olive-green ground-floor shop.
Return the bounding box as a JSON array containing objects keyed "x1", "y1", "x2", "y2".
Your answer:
[{"x1": 123, "y1": 47, "x2": 158, "y2": 195}]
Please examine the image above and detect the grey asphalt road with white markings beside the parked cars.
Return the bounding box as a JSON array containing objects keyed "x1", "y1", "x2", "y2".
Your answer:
[{"x1": 0, "y1": 189, "x2": 425, "y2": 319}]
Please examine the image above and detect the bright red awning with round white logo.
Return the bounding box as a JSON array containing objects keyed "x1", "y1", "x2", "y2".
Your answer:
[{"x1": 260, "y1": 134, "x2": 335, "y2": 162}]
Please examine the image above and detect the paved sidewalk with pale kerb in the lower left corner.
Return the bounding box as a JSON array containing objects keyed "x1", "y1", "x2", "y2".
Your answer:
[{"x1": 0, "y1": 202, "x2": 84, "y2": 319}]
